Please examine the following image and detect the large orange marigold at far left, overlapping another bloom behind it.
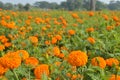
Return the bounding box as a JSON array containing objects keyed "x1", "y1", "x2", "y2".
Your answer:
[{"x1": 0, "y1": 52, "x2": 21, "y2": 69}]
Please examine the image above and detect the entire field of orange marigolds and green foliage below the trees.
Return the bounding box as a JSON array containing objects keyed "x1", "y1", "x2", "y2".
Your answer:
[{"x1": 0, "y1": 10, "x2": 120, "y2": 80}]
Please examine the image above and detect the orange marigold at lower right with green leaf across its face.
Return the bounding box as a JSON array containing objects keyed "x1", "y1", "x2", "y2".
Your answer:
[{"x1": 91, "y1": 57, "x2": 106, "y2": 68}]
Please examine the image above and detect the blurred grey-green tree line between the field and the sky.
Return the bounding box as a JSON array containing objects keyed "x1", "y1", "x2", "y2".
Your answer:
[{"x1": 0, "y1": 0, "x2": 120, "y2": 11}]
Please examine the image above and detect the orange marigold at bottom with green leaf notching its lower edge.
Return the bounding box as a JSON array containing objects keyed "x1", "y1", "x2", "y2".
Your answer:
[{"x1": 34, "y1": 64, "x2": 49, "y2": 79}]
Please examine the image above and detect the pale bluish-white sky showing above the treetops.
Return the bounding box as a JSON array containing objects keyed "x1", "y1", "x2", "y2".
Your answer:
[{"x1": 0, "y1": 0, "x2": 120, "y2": 4}]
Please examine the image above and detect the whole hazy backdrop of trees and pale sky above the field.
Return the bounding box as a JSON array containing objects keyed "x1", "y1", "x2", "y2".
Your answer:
[{"x1": 0, "y1": 0, "x2": 120, "y2": 11}]
